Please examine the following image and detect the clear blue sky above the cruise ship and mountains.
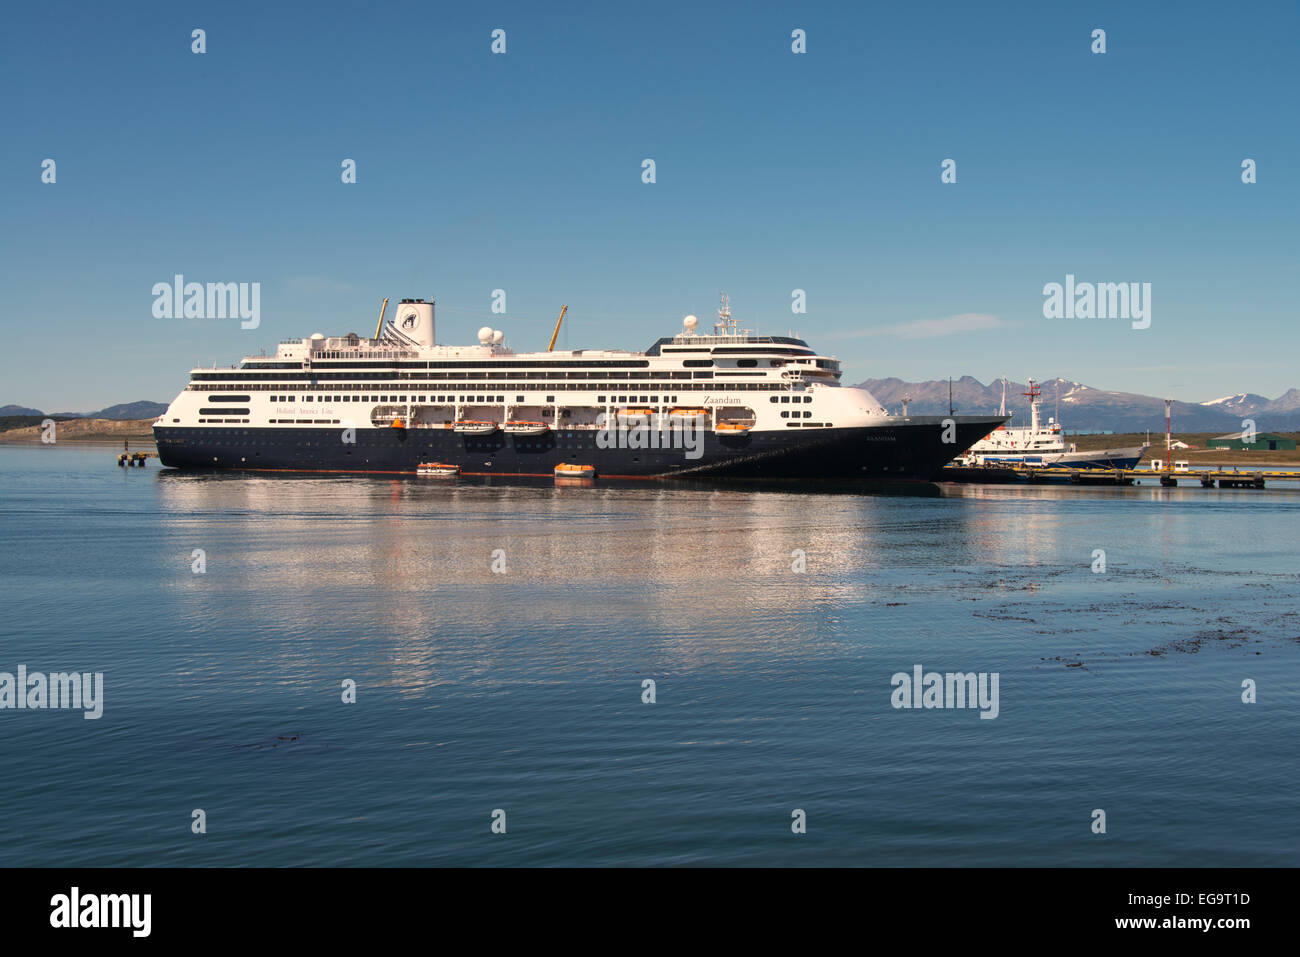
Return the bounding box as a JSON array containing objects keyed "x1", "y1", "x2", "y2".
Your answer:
[{"x1": 0, "y1": 3, "x2": 1300, "y2": 411}]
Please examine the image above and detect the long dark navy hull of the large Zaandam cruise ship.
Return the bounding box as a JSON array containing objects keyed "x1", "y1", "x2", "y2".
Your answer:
[{"x1": 153, "y1": 416, "x2": 1002, "y2": 481}]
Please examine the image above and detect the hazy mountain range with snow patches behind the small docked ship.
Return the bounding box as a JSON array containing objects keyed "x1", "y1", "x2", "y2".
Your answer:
[{"x1": 858, "y1": 376, "x2": 1300, "y2": 434}]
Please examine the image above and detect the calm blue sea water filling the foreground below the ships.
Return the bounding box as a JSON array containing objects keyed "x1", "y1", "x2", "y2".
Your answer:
[{"x1": 0, "y1": 445, "x2": 1300, "y2": 866}]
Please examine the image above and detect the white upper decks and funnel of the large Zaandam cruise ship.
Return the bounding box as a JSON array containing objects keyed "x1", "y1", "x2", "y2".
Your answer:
[{"x1": 156, "y1": 296, "x2": 891, "y2": 432}]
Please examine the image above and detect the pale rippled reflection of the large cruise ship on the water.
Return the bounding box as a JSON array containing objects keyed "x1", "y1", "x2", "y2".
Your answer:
[{"x1": 159, "y1": 472, "x2": 970, "y2": 694}]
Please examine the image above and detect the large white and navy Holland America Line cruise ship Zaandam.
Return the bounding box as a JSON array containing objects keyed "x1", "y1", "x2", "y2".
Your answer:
[{"x1": 153, "y1": 295, "x2": 1006, "y2": 482}]
